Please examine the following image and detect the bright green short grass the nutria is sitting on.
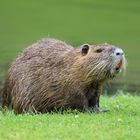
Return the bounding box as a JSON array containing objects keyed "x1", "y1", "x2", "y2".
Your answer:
[{"x1": 0, "y1": 94, "x2": 140, "y2": 140}]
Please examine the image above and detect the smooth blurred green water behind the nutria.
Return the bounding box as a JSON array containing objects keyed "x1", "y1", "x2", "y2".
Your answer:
[{"x1": 0, "y1": 0, "x2": 140, "y2": 91}]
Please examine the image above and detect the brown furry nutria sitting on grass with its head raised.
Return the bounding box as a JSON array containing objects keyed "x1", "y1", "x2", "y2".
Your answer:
[{"x1": 2, "y1": 38, "x2": 125, "y2": 113}]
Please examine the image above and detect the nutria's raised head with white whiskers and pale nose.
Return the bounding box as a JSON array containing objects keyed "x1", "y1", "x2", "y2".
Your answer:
[{"x1": 81, "y1": 44, "x2": 126, "y2": 80}]
